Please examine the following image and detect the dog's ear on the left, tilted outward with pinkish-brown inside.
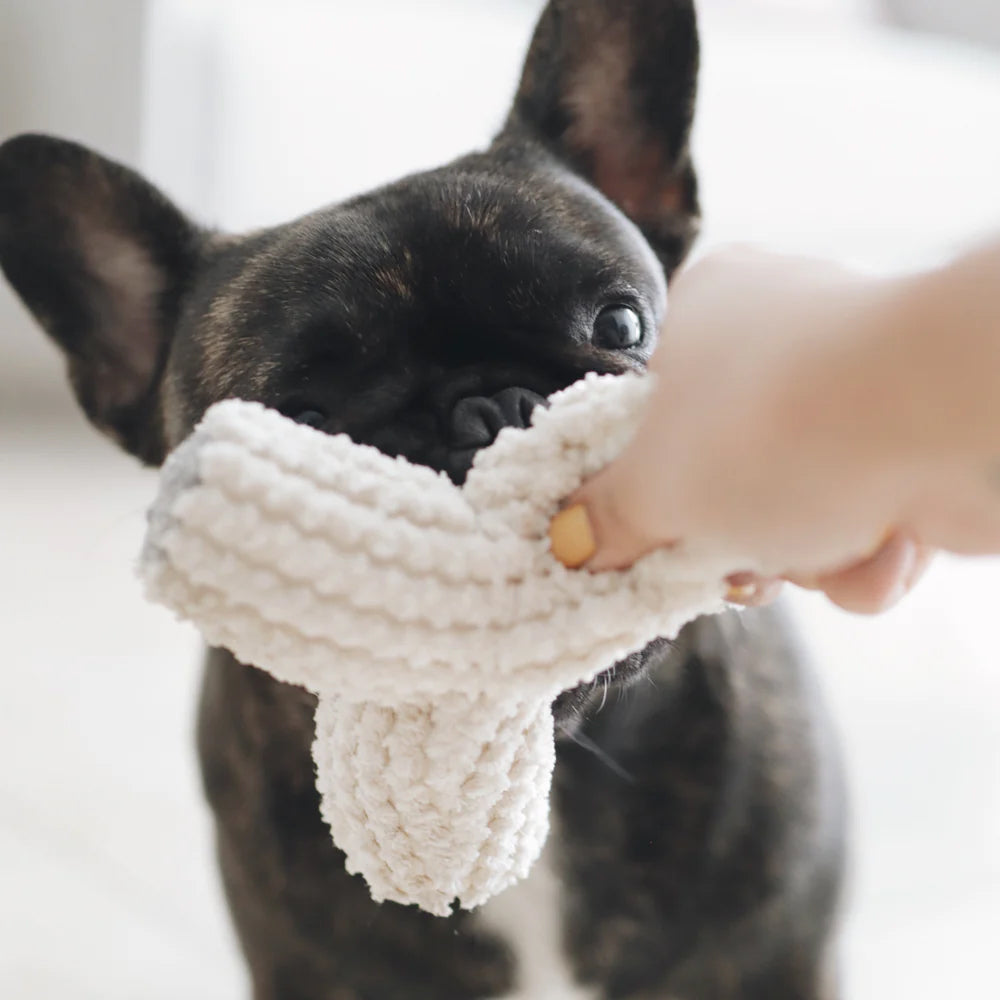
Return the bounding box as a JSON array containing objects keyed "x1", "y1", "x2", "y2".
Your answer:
[{"x1": 0, "y1": 135, "x2": 201, "y2": 463}]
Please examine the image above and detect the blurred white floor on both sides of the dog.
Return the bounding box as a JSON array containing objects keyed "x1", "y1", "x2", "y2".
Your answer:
[{"x1": 0, "y1": 408, "x2": 1000, "y2": 1000}]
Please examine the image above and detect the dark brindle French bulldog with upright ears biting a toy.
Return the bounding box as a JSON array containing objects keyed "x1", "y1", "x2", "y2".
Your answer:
[{"x1": 0, "y1": 0, "x2": 843, "y2": 1000}]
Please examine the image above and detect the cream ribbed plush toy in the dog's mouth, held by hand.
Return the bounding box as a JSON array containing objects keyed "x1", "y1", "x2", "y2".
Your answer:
[{"x1": 141, "y1": 376, "x2": 726, "y2": 915}]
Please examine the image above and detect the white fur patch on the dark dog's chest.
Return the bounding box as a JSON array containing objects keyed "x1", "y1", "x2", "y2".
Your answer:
[{"x1": 476, "y1": 848, "x2": 597, "y2": 1000}]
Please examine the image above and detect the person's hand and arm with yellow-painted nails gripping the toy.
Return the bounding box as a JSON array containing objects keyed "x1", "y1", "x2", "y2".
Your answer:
[{"x1": 553, "y1": 241, "x2": 1000, "y2": 612}]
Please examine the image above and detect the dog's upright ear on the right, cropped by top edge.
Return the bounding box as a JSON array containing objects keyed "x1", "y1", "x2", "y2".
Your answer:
[{"x1": 501, "y1": 0, "x2": 699, "y2": 274}]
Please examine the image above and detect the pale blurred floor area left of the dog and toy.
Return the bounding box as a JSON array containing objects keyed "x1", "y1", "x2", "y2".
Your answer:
[{"x1": 0, "y1": 410, "x2": 246, "y2": 1000}]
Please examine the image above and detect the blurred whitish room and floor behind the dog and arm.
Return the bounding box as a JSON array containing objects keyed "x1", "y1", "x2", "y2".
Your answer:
[{"x1": 0, "y1": 0, "x2": 1000, "y2": 1000}]
